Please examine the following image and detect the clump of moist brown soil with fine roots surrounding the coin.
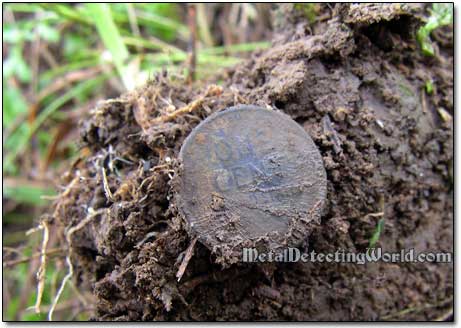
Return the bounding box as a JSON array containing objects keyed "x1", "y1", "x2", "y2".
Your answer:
[{"x1": 47, "y1": 4, "x2": 453, "y2": 320}]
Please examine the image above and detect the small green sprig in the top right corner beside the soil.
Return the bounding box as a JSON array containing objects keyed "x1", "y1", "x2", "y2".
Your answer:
[{"x1": 416, "y1": 3, "x2": 453, "y2": 56}]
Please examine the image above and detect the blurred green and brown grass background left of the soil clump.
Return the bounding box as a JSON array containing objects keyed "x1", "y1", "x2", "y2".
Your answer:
[{"x1": 2, "y1": 3, "x2": 271, "y2": 320}]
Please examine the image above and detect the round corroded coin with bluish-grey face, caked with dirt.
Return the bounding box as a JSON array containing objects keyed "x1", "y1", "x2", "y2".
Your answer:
[{"x1": 178, "y1": 106, "x2": 326, "y2": 262}]
